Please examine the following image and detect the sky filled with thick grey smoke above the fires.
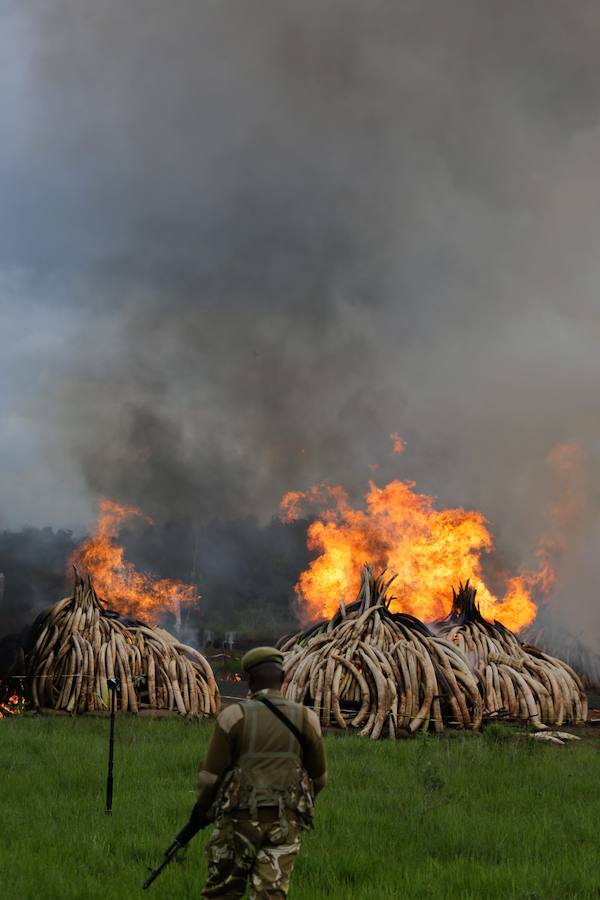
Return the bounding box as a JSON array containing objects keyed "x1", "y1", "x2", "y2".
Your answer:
[{"x1": 0, "y1": 0, "x2": 600, "y2": 632}]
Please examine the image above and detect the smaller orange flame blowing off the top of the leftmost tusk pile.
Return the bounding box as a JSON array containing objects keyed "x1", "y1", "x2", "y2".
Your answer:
[{"x1": 69, "y1": 498, "x2": 199, "y2": 625}]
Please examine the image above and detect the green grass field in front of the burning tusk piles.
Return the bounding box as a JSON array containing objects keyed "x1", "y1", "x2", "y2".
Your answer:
[{"x1": 0, "y1": 717, "x2": 600, "y2": 900}]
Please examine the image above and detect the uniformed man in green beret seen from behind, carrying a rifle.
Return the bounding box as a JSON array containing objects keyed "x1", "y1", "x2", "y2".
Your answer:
[{"x1": 196, "y1": 647, "x2": 327, "y2": 900}]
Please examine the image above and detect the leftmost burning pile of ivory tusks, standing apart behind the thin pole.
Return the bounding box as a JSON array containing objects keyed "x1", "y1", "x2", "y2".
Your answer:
[{"x1": 26, "y1": 575, "x2": 219, "y2": 716}]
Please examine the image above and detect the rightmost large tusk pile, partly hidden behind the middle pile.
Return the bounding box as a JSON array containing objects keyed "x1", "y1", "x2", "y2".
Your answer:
[{"x1": 438, "y1": 581, "x2": 587, "y2": 729}]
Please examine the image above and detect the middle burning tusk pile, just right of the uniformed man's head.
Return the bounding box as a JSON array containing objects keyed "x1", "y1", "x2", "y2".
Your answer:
[{"x1": 280, "y1": 566, "x2": 483, "y2": 740}]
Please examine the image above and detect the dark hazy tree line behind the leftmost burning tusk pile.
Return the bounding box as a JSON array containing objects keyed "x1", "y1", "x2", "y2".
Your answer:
[{"x1": 0, "y1": 517, "x2": 309, "y2": 643}]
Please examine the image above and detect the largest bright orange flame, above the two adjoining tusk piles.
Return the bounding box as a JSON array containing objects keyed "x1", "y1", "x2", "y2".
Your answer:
[{"x1": 281, "y1": 481, "x2": 554, "y2": 630}]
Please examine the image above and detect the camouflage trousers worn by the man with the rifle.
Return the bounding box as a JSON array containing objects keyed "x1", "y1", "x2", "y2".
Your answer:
[{"x1": 202, "y1": 810, "x2": 301, "y2": 900}]
